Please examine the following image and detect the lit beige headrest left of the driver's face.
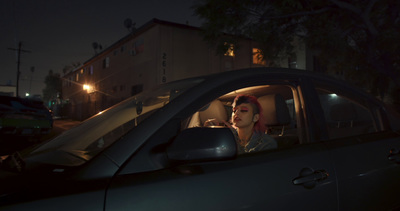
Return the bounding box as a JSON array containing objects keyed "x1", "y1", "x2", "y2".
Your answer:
[{"x1": 199, "y1": 100, "x2": 228, "y2": 125}]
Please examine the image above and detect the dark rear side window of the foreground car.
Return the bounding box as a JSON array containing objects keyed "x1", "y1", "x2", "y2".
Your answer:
[{"x1": 317, "y1": 89, "x2": 377, "y2": 139}]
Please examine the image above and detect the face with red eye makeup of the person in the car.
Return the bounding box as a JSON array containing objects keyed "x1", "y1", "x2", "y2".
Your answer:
[{"x1": 232, "y1": 103, "x2": 259, "y2": 128}]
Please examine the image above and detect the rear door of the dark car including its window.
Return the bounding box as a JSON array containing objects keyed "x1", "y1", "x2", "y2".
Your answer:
[{"x1": 316, "y1": 80, "x2": 400, "y2": 210}]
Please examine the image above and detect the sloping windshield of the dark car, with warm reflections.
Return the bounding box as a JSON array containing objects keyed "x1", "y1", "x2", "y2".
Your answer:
[{"x1": 30, "y1": 79, "x2": 202, "y2": 166}]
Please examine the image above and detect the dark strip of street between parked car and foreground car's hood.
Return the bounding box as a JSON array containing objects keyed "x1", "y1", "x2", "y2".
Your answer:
[{"x1": 0, "y1": 119, "x2": 80, "y2": 156}]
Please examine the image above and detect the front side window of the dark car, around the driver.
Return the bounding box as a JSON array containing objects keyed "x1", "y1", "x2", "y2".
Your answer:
[{"x1": 121, "y1": 84, "x2": 304, "y2": 174}]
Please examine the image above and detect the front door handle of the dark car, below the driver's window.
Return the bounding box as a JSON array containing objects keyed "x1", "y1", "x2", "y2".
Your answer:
[{"x1": 292, "y1": 168, "x2": 329, "y2": 189}]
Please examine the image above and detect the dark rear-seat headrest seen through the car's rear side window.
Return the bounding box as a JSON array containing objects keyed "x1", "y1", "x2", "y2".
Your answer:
[{"x1": 329, "y1": 103, "x2": 357, "y2": 121}]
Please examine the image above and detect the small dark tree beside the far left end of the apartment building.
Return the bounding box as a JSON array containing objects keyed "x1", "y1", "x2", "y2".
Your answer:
[{"x1": 43, "y1": 70, "x2": 62, "y2": 102}]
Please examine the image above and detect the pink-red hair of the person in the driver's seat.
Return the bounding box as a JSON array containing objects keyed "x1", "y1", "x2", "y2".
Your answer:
[{"x1": 232, "y1": 94, "x2": 267, "y2": 133}]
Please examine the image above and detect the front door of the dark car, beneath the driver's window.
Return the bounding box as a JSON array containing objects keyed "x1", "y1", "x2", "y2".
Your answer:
[{"x1": 105, "y1": 79, "x2": 337, "y2": 210}]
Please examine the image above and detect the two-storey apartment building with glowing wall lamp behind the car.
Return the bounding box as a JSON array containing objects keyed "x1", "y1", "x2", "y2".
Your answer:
[{"x1": 63, "y1": 19, "x2": 305, "y2": 120}]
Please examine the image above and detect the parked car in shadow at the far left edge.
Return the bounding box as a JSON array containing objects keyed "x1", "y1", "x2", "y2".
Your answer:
[{"x1": 0, "y1": 96, "x2": 53, "y2": 136}]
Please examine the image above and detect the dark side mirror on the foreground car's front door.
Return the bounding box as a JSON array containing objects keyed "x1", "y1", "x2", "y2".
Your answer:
[{"x1": 167, "y1": 127, "x2": 237, "y2": 163}]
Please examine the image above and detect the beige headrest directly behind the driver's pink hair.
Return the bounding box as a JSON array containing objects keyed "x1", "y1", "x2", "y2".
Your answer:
[{"x1": 258, "y1": 94, "x2": 290, "y2": 126}]
